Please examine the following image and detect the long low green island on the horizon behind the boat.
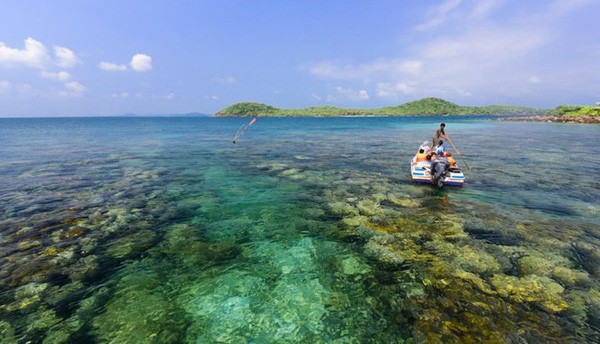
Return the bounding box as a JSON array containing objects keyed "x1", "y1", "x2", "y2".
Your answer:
[{"x1": 215, "y1": 98, "x2": 546, "y2": 117}]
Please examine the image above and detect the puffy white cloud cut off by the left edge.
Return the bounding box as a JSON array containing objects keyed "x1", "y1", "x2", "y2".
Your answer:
[{"x1": 0, "y1": 37, "x2": 51, "y2": 69}]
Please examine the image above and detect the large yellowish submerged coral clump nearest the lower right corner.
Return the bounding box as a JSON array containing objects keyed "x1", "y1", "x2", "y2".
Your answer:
[{"x1": 490, "y1": 274, "x2": 568, "y2": 313}]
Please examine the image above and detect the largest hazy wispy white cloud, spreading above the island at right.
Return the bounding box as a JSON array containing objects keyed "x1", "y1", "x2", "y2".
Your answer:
[{"x1": 309, "y1": 0, "x2": 599, "y2": 102}]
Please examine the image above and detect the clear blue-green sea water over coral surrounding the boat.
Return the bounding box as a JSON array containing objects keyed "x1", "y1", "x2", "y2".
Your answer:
[{"x1": 0, "y1": 117, "x2": 600, "y2": 343}]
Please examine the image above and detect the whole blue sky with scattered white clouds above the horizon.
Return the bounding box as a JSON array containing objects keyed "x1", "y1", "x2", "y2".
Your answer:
[{"x1": 0, "y1": 0, "x2": 600, "y2": 116}]
